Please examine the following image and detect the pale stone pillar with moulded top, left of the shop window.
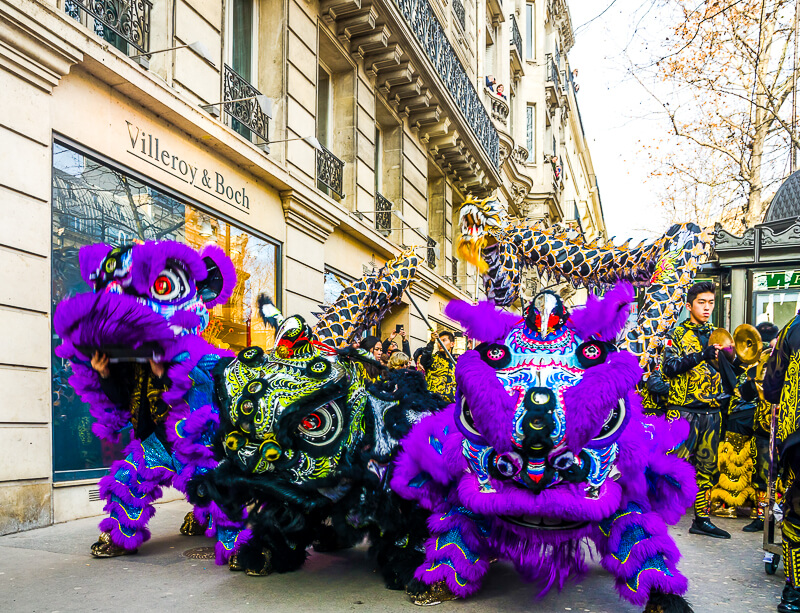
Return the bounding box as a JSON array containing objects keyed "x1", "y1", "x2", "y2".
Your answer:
[{"x1": 0, "y1": 0, "x2": 82, "y2": 534}]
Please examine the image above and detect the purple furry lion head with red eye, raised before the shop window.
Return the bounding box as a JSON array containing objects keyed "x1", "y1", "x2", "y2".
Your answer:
[{"x1": 53, "y1": 241, "x2": 236, "y2": 361}]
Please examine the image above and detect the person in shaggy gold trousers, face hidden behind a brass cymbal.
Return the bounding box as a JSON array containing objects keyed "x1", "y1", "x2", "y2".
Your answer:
[{"x1": 711, "y1": 322, "x2": 778, "y2": 532}]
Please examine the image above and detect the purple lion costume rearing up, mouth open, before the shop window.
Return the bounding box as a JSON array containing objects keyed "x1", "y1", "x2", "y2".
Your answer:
[{"x1": 53, "y1": 241, "x2": 249, "y2": 562}]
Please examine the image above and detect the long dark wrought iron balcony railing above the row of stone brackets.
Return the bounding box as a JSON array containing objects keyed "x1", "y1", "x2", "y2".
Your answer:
[{"x1": 394, "y1": 0, "x2": 500, "y2": 168}]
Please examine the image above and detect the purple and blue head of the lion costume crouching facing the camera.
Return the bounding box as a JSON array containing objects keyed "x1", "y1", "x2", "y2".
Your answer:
[{"x1": 446, "y1": 284, "x2": 641, "y2": 543}]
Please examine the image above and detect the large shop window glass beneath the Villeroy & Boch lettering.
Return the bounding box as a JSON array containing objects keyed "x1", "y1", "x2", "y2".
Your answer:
[{"x1": 52, "y1": 143, "x2": 280, "y2": 481}]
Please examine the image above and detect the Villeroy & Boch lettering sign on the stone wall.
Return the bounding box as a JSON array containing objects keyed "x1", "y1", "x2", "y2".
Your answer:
[{"x1": 125, "y1": 121, "x2": 250, "y2": 213}]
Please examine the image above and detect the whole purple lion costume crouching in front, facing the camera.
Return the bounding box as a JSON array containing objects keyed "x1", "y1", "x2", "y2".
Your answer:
[{"x1": 391, "y1": 284, "x2": 697, "y2": 613}]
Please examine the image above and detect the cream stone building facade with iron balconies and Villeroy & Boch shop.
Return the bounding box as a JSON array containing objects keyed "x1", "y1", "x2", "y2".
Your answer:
[{"x1": 0, "y1": 0, "x2": 605, "y2": 534}]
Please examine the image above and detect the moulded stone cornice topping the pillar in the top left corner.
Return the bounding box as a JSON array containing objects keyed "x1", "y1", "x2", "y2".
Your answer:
[{"x1": 0, "y1": 0, "x2": 83, "y2": 93}]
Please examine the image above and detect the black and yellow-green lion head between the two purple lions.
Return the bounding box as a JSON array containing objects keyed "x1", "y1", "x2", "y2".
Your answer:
[{"x1": 216, "y1": 315, "x2": 367, "y2": 485}]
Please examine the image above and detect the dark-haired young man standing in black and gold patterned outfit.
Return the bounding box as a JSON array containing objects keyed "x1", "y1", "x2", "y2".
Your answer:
[{"x1": 661, "y1": 281, "x2": 731, "y2": 539}]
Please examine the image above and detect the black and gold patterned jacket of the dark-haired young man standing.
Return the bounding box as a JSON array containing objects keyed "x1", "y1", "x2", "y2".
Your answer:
[{"x1": 662, "y1": 321, "x2": 722, "y2": 410}]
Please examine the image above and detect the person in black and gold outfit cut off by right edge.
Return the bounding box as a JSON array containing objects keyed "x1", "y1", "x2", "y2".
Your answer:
[{"x1": 763, "y1": 313, "x2": 800, "y2": 613}]
